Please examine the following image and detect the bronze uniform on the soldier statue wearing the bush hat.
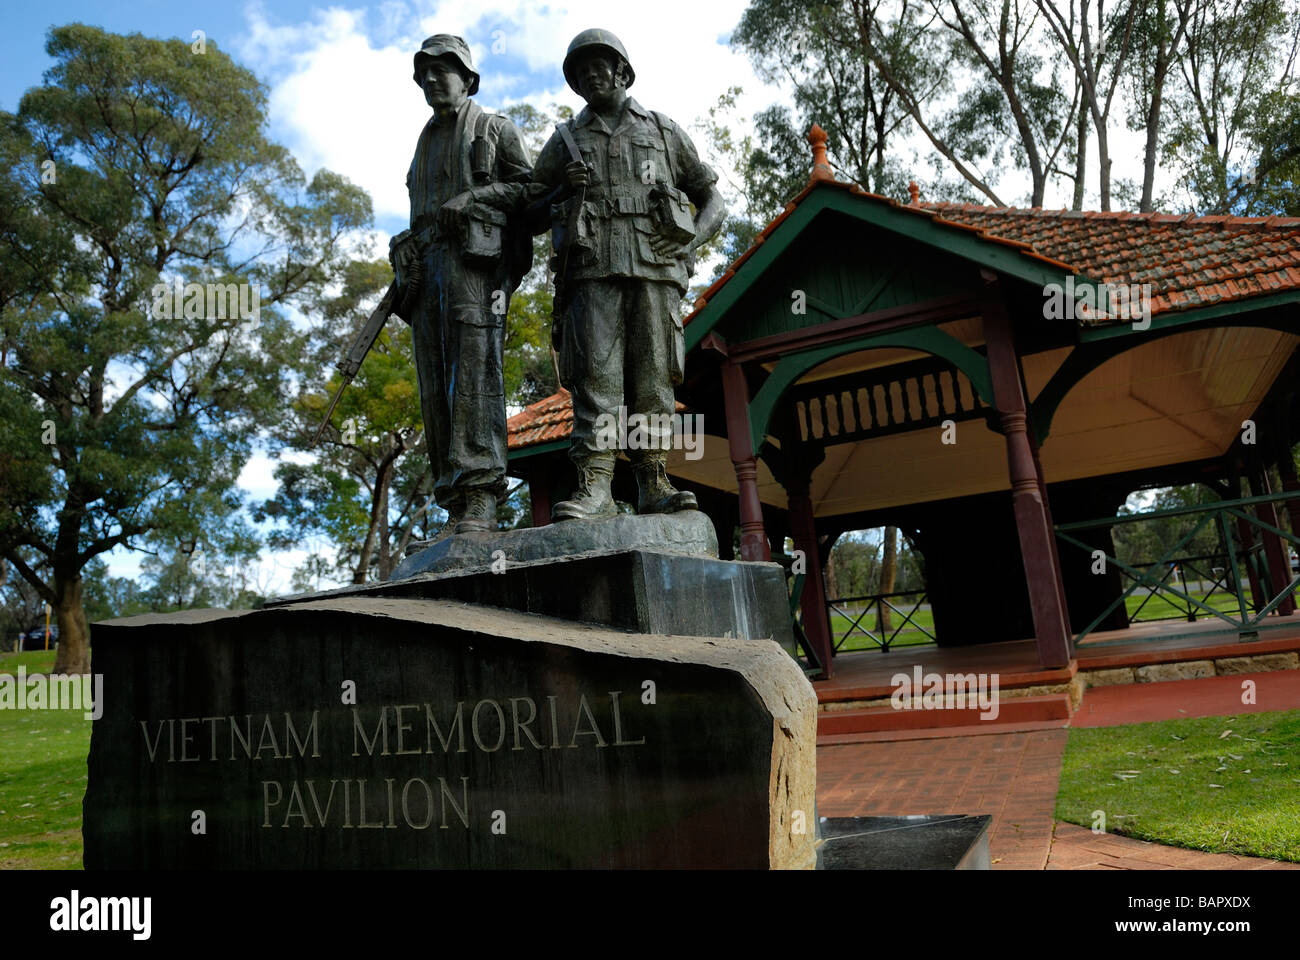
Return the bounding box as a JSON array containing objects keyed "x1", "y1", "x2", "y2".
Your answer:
[{"x1": 398, "y1": 43, "x2": 532, "y2": 518}]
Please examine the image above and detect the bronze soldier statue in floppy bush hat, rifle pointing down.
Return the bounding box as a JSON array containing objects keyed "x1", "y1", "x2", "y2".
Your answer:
[{"x1": 390, "y1": 34, "x2": 533, "y2": 542}]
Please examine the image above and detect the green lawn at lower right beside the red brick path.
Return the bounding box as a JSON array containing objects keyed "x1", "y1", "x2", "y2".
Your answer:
[{"x1": 1057, "y1": 710, "x2": 1300, "y2": 861}]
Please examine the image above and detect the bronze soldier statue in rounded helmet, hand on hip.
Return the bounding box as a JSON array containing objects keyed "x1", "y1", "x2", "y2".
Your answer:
[{"x1": 533, "y1": 30, "x2": 727, "y2": 520}]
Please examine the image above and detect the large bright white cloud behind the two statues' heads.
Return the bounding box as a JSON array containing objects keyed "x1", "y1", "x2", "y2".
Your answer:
[{"x1": 239, "y1": 0, "x2": 777, "y2": 222}]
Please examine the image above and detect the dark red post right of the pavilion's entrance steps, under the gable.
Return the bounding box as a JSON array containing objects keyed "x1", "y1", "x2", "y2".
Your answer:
[{"x1": 983, "y1": 272, "x2": 1071, "y2": 667}]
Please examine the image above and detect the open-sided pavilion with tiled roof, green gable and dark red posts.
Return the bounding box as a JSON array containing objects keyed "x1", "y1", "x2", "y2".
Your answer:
[{"x1": 510, "y1": 127, "x2": 1300, "y2": 678}]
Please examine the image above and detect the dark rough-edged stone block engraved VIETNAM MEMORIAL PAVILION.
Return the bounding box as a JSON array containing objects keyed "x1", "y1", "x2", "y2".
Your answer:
[{"x1": 83, "y1": 595, "x2": 816, "y2": 869}]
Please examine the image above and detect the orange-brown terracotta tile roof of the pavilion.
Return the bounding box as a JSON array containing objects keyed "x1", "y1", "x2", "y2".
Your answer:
[{"x1": 507, "y1": 180, "x2": 1300, "y2": 450}]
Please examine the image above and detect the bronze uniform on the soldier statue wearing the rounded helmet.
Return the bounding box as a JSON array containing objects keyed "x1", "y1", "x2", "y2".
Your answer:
[{"x1": 533, "y1": 96, "x2": 718, "y2": 464}]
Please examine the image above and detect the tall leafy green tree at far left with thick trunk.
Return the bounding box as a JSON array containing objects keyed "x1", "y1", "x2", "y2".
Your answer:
[{"x1": 0, "y1": 23, "x2": 371, "y2": 666}]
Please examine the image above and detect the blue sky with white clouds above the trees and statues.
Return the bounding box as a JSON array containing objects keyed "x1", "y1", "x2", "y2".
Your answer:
[{"x1": 0, "y1": 0, "x2": 1164, "y2": 592}]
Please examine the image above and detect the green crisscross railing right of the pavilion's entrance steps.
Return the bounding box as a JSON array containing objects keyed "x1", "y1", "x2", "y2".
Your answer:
[{"x1": 1056, "y1": 493, "x2": 1300, "y2": 643}]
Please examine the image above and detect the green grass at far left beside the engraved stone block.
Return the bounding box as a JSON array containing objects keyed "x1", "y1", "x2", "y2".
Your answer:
[{"x1": 0, "y1": 650, "x2": 91, "y2": 870}]
